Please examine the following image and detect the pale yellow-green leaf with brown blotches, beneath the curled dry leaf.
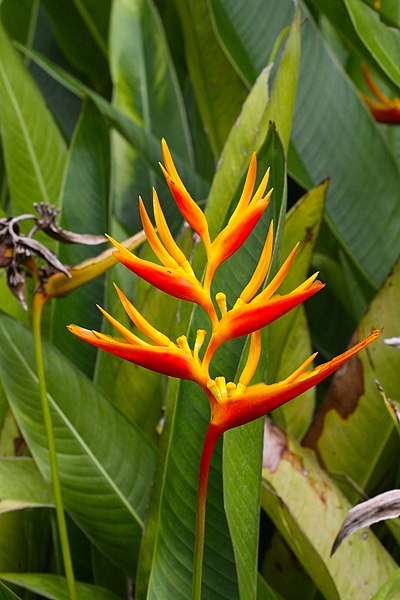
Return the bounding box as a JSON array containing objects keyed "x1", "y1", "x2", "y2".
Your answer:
[{"x1": 261, "y1": 424, "x2": 396, "y2": 600}]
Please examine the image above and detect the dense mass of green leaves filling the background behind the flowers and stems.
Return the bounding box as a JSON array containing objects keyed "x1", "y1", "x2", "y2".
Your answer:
[{"x1": 0, "y1": 0, "x2": 400, "y2": 600}]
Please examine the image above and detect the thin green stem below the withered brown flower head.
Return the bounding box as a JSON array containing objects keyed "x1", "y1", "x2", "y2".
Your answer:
[{"x1": 32, "y1": 293, "x2": 76, "y2": 600}]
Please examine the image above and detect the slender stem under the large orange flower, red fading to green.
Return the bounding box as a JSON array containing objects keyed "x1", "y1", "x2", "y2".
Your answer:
[{"x1": 192, "y1": 423, "x2": 223, "y2": 600}]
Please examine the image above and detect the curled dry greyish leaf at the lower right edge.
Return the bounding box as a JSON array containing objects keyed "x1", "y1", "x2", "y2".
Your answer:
[{"x1": 331, "y1": 490, "x2": 400, "y2": 556}]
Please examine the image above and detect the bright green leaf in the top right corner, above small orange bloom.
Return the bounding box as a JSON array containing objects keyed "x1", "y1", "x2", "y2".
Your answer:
[{"x1": 344, "y1": 0, "x2": 400, "y2": 87}]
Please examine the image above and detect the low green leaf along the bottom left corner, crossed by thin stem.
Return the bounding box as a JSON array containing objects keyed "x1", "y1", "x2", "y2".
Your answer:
[{"x1": 0, "y1": 573, "x2": 118, "y2": 600}]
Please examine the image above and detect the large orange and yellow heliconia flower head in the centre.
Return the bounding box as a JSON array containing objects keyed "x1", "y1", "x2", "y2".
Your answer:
[{"x1": 69, "y1": 140, "x2": 380, "y2": 432}]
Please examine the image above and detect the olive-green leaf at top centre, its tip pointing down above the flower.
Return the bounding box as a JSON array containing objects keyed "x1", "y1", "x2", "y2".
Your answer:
[{"x1": 175, "y1": 0, "x2": 246, "y2": 157}]
